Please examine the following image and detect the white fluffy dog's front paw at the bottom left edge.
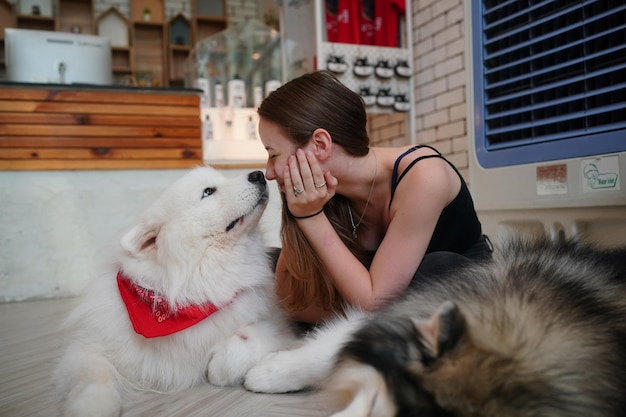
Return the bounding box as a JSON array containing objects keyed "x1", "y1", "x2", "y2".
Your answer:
[{"x1": 63, "y1": 383, "x2": 122, "y2": 417}]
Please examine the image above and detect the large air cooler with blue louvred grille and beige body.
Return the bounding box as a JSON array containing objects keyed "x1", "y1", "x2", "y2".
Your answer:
[{"x1": 465, "y1": 0, "x2": 626, "y2": 244}]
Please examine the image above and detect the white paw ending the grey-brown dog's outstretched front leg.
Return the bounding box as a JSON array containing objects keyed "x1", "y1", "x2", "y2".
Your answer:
[{"x1": 244, "y1": 350, "x2": 311, "y2": 394}]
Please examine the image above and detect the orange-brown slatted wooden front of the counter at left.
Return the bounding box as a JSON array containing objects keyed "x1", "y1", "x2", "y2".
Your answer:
[{"x1": 0, "y1": 86, "x2": 202, "y2": 170}]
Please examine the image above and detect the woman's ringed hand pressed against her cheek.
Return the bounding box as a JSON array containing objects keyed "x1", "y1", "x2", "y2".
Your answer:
[{"x1": 283, "y1": 149, "x2": 338, "y2": 217}]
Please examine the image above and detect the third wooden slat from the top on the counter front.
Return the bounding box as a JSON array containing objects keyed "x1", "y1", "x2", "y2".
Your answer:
[{"x1": 0, "y1": 112, "x2": 201, "y2": 127}]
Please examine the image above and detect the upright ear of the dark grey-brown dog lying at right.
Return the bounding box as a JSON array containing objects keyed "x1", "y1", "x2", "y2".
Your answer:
[{"x1": 413, "y1": 301, "x2": 466, "y2": 359}]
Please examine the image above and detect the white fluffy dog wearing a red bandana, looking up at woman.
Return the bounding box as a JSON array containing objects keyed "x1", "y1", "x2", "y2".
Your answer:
[{"x1": 54, "y1": 167, "x2": 295, "y2": 417}]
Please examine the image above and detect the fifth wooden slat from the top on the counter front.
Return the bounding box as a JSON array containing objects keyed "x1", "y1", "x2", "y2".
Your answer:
[{"x1": 0, "y1": 136, "x2": 201, "y2": 148}]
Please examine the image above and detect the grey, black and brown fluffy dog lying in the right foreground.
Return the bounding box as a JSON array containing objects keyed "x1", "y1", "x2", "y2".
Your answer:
[{"x1": 246, "y1": 240, "x2": 626, "y2": 417}]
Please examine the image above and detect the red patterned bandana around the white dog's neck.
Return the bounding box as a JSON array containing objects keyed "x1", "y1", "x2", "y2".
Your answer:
[{"x1": 117, "y1": 271, "x2": 219, "y2": 338}]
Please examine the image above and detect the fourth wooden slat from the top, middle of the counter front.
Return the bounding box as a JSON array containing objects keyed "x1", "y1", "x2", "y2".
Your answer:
[{"x1": 0, "y1": 124, "x2": 201, "y2": 139}]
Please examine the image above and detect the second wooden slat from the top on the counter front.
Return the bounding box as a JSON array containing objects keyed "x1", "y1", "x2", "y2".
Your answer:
[{"x1": 0, "y1": 102, "x2": 199, "y2": 117}]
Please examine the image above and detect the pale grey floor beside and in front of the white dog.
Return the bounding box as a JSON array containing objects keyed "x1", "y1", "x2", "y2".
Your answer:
[{"x1": 0, "y1": 299, "x2": 330, "y2": 417}]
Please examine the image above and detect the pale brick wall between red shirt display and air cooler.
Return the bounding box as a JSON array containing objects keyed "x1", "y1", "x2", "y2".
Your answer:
[{"x1": 368, "y1": 0, "x2": 469, "y2": 180}]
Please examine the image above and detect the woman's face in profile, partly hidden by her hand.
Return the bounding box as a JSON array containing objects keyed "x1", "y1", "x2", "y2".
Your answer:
[{"x1": 259, "y1": 118, "x2": 308, "y2": 192}]
